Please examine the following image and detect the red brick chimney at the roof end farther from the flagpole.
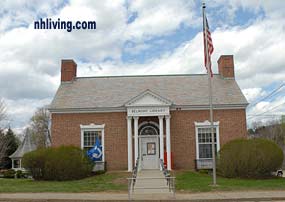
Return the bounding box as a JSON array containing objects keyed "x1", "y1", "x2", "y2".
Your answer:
[{"x1": 61, "y1": 60, "x2": 77, "y2": 82}]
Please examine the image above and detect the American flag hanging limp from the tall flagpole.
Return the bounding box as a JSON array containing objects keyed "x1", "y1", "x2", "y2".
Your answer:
[{"x1": 203, "y1": 16, "x2": 214, "y2": 77}]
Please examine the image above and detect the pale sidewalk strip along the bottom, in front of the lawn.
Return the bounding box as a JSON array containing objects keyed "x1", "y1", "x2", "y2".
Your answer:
[{"x1": 0, "y1": 191, "x2": 285, "y2": 202}]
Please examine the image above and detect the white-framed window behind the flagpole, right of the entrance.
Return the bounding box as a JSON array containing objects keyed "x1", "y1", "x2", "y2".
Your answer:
[{"x1": 195, "y1": 121, "x2": 220, "y2": 159}]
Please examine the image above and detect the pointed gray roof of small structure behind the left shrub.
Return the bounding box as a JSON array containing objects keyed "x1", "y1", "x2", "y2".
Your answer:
[{"x1": 9, "y1": 131, "x2": 37, "y2": 159}]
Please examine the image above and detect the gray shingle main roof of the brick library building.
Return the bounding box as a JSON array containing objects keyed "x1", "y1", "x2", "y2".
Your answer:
[{"x1": 50, "y1": 74, "x2": 247, "y2": 109}]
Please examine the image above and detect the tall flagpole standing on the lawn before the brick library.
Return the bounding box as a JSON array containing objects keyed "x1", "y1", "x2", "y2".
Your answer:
[{"x1": 202, "y1": 3, "x2": 217, "y2": 185}]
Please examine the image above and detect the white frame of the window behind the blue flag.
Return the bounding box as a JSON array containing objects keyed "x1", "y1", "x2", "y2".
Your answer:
[{"x1": 80, "y1": 123, "x2": 105, "y2": 162}]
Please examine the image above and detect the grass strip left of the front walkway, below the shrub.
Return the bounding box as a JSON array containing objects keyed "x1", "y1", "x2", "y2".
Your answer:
[{"x1": 0, "y1": 172, "x2": 129, "y2": 193}]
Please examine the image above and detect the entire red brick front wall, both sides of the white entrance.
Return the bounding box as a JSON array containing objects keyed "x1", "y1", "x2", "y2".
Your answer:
[{"x1": 52, "y1": 109, "x2": 246, "y2": 170}]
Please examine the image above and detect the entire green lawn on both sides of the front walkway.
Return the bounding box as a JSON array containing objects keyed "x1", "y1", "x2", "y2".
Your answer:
[{"x1": 0, "y1": 171, "x2": 285, "y2": 193}]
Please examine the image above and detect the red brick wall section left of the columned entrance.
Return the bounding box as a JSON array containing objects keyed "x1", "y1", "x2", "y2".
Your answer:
[{"x1": 51, "y1": 112, "x2": 128, "y2": 170}]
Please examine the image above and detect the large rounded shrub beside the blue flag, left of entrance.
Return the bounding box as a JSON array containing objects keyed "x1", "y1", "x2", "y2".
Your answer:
[{"x1": 23, "y1": 146, "x2": 93, "y2": 181}]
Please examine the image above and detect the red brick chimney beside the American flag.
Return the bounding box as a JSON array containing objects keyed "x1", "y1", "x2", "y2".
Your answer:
[{"x1": 218, "y1": 55, "x2": 235, "y2": 79}]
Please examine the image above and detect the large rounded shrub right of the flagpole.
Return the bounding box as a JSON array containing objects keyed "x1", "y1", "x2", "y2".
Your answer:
[{"x1": 217, "y1": 138, "x2": 283, "y2": 178}]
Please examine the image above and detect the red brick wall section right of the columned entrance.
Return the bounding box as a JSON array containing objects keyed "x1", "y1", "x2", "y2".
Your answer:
[{"x1": 170, "y1": 109, "x2": 246, "y2": 169}]
